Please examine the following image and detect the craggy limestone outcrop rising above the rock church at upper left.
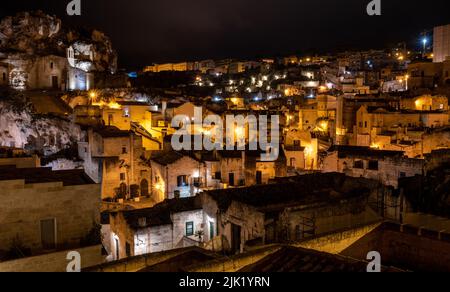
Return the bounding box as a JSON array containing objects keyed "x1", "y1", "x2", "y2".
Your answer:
[{"x1": 0, "y1": 11, "x2": 117, "y2": 73}]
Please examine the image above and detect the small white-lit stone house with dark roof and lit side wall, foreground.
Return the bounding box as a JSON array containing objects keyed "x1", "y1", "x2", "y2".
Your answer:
[{"x1": 104, "y1": 197, "x2": 206, "y2": 260}]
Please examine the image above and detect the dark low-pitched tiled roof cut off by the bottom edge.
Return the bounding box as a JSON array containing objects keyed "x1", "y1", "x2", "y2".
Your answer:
[{"x1": 239, "y1": 247, "x2": 398, "y2": 273}]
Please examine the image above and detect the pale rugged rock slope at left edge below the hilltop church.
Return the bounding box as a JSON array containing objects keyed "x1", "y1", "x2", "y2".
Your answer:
[{"x1": 0, "y1": 100, "x2": 85, "y2": 155}]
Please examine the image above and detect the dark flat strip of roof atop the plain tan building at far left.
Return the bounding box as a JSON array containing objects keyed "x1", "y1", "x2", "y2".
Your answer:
[{"x1": 0, "y1": 166, "x2": 95, "y2": 186}]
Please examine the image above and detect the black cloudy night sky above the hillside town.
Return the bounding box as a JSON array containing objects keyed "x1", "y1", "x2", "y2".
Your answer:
[{"x1": 0, "y1": 0, "x2": 450, "y2": 68}]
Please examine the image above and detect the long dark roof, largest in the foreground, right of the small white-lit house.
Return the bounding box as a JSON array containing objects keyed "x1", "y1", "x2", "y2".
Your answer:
[{"x1": 206, "y1": 173, "x2": 372, "y2": 211}]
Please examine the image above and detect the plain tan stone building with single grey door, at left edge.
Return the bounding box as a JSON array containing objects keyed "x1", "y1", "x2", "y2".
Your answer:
[{"x1": 0, "y1": 166, "x2": 103, "y2": 272}]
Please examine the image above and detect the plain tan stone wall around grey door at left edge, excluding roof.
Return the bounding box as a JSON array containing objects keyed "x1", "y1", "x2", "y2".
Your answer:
[{"x1": 0, "y1": 180, "x2": 100, "y2": 253}]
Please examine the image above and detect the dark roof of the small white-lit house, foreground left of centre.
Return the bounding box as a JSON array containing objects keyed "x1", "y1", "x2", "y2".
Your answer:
[{"x1": 123, "y1": 197, "x2": 202, "y2": 230}]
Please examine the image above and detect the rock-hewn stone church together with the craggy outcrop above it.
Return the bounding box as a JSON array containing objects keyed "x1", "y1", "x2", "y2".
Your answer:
[{"x1": 0, "y1": 11, "x2": 117, "y2": 90}]
